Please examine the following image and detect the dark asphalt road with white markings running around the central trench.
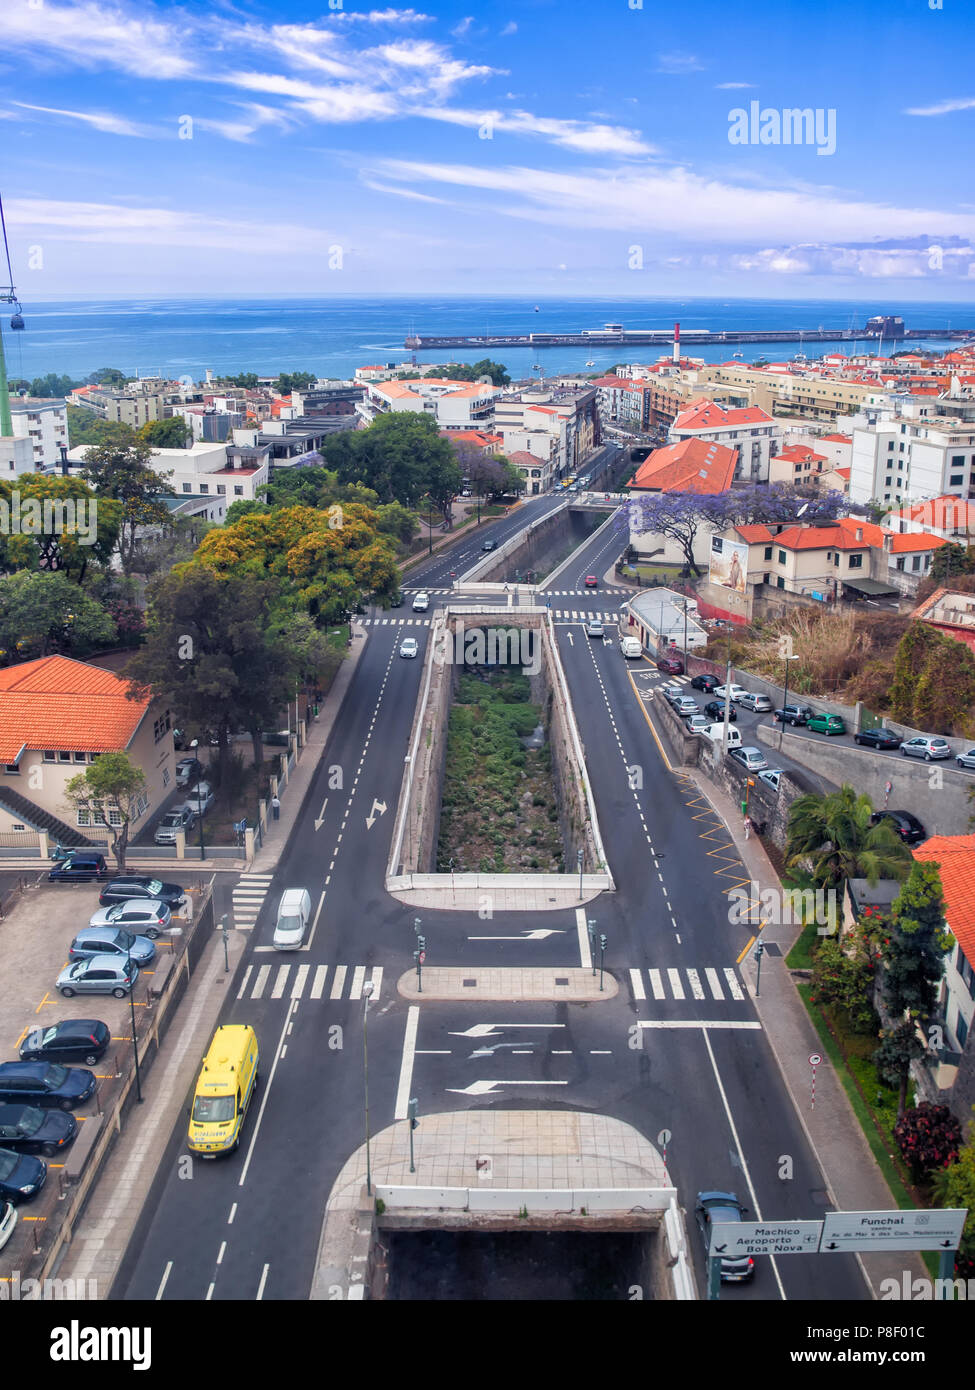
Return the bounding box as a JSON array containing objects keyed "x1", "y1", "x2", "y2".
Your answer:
[{"x1": 114, "y1": 475, "x2": 865, "y2": 1301}]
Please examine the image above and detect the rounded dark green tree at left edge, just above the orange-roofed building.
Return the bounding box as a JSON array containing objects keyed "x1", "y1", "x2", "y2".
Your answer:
[{"x1": 0, "y1": 570, "x2": 115, "y2": 660}]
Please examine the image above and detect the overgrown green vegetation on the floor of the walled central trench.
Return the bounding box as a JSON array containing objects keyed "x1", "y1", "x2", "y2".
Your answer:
[{"x1": 437, "y1": 666, "x2": 563, "y2": 873}]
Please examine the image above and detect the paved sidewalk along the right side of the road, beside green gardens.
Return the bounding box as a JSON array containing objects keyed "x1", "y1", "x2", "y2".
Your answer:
[{"x1": 682, "y1": 767, "x2": 928, "y2": 1298}]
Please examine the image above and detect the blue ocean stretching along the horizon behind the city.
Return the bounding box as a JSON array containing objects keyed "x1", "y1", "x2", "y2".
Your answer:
[{"x1": 4, "y1": 296, "x2": 975, "y2": 379}]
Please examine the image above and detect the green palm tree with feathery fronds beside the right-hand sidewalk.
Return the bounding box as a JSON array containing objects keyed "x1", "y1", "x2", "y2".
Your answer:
[{"x1": 786, "y1": 784, "x2": 914, "y2": 888}]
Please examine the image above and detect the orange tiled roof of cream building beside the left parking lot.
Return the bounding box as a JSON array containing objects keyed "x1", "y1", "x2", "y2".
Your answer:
[{"x1": 0, "y1": 656, "x2": 149, "y2": 763}]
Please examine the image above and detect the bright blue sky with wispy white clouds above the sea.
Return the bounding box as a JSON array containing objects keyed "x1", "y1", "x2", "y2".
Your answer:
[{"x1": 0, "y1": 0, "x2": 975, "y2": 302}]
